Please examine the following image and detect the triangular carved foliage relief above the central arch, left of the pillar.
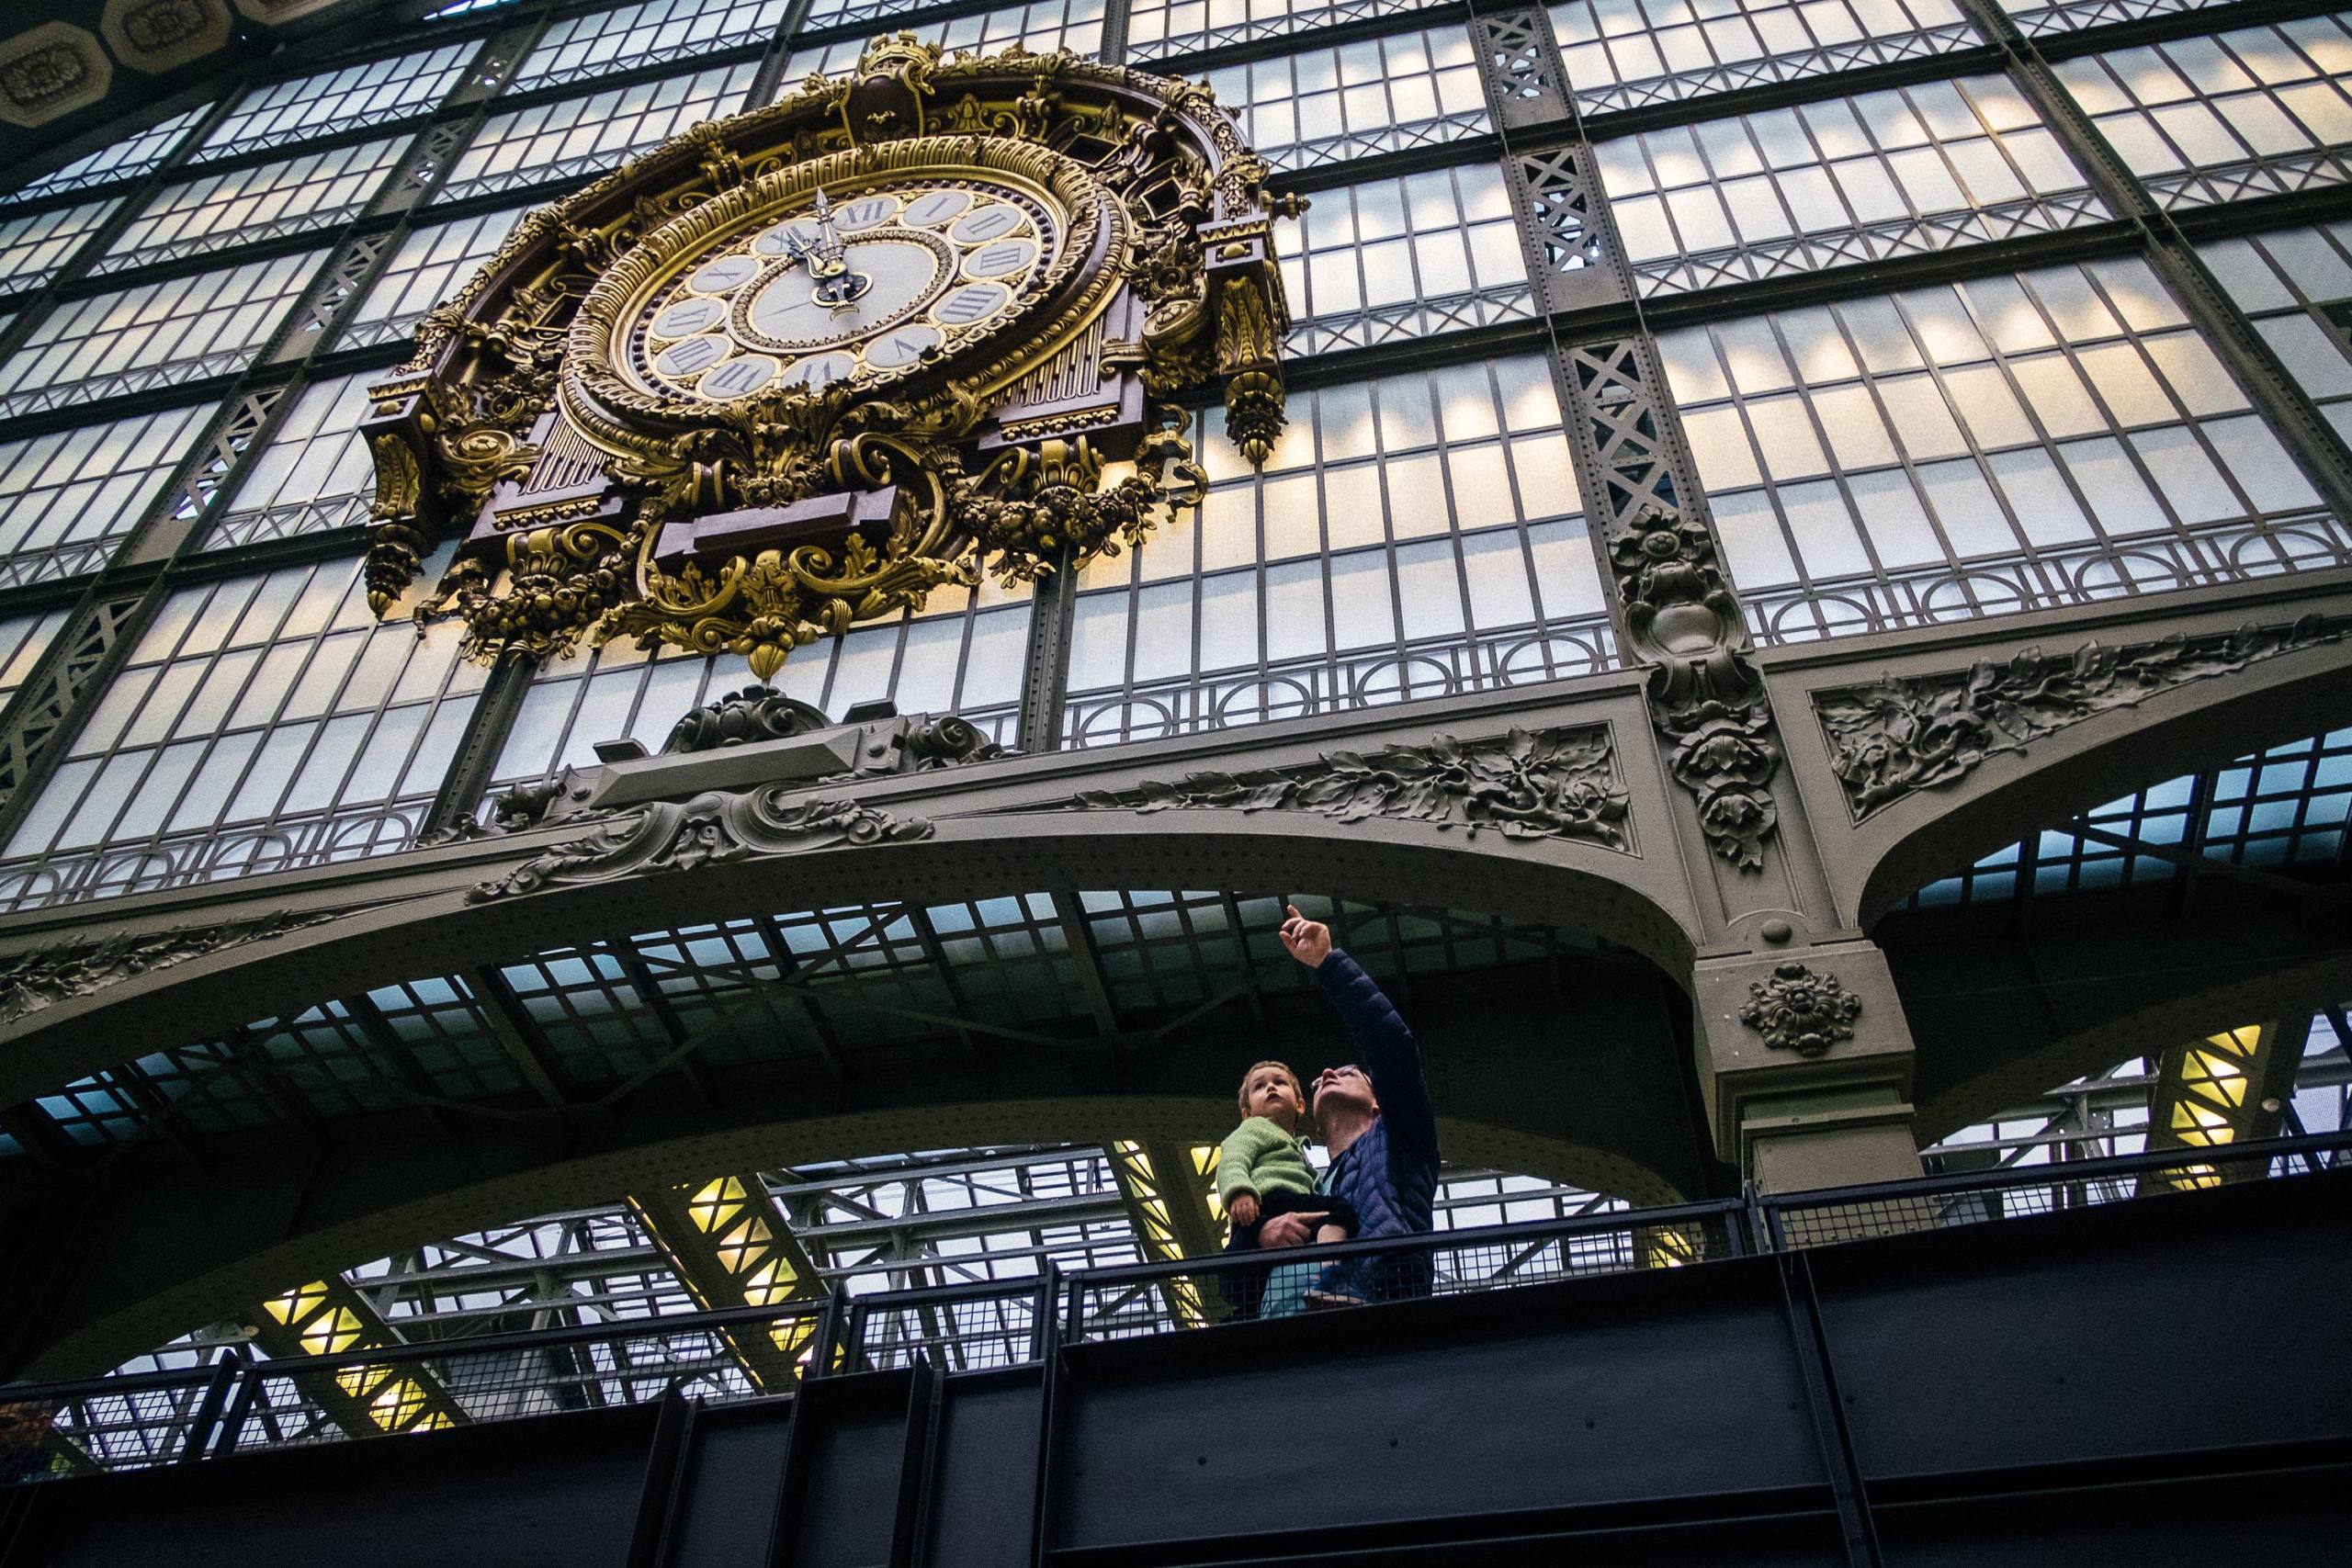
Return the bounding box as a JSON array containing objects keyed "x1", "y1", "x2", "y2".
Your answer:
[{"x1": 1070, "y1": 728, "x2": 1633, "y2": 851}]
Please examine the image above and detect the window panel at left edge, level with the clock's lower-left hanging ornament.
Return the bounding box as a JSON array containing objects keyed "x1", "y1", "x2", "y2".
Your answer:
[{"x1": 0, "y1": 404, "x2": 214, "y2": 585}]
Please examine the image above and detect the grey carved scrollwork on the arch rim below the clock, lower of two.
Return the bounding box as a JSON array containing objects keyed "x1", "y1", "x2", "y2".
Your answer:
[{"x1": 466, "y1": 787, "x2": 932, "y2": 903}]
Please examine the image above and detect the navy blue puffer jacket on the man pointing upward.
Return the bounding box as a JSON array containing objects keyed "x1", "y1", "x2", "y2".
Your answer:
[{"x1": 1315, "y1": 947, "x2": 1437, "y2": 1300}]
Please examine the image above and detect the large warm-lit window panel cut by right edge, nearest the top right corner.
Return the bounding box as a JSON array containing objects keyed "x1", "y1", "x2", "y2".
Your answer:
[{"x1": 2055, "y1": 17, "x2": 2352, "y2": 209}]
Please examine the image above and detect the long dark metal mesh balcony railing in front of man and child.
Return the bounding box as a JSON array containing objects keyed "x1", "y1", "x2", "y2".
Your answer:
[{"x1": 0, "y1": 1134, "x2": 2352, "y2": 1483}]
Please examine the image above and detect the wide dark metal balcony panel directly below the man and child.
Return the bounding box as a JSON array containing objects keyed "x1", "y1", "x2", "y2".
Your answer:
[{"x1": 1054, "y1": 1262, "x2": 1826, "y2": 1547}]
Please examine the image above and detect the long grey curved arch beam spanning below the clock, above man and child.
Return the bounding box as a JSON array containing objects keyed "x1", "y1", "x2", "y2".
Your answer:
[{"x1": 0, "y1": 811, "x2": 1698, "y2": 1105}]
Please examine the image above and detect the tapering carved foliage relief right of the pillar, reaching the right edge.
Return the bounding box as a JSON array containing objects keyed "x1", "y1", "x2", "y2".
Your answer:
[{"x1": 1814, "y1": 616, "x2": 2352, "y2": 820}]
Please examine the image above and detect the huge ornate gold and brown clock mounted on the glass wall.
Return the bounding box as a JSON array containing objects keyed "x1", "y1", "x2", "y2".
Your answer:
[{"x1": 365, "y1": 35, "x2": 1296, "y2": 680}]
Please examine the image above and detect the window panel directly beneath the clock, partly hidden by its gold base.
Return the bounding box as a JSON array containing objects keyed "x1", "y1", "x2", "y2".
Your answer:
[{"x1": 480, "y1": 581, "x2": 1030, "y2": 787}]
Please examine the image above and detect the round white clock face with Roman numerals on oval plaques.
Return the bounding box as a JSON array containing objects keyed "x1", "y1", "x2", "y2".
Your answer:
[{"x1": 614, "y1": 172, "x2": 1068, "y2": 402}]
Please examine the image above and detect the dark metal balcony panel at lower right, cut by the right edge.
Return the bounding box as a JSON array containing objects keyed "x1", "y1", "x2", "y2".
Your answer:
[{"x1": 1814, "y1": 1176, "x2": 2352, "y2": 1479}]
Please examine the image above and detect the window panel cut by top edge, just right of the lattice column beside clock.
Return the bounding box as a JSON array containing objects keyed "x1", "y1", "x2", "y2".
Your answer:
[{"x1": 1550, "y1": 0, "x2": 1978, "y2": 113}]
